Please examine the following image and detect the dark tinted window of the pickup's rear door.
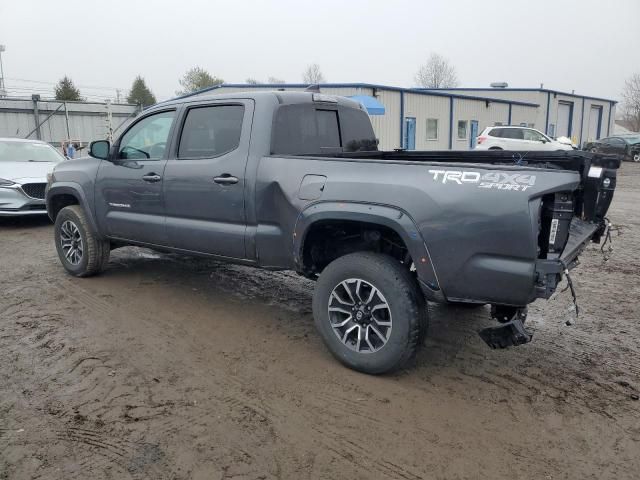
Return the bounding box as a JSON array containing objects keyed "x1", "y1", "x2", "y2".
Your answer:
[{"x1": 178, "y1": 105, "x2": 244, "y2": 158}]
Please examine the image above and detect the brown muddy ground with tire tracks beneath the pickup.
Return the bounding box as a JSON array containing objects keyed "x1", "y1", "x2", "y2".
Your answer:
[{"x1": 0, "y1": 164, "x2": 640, "y2": 480}]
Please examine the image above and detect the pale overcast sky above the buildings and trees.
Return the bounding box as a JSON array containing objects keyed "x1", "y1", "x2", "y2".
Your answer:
[{"x1": 0, "y1": 0, "x2": 640, "y2": 100}]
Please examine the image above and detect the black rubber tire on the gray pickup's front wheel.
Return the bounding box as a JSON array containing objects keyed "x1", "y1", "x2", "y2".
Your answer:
[{"x1": 54, "y1": 205, "x2": 111, "y2": 277}]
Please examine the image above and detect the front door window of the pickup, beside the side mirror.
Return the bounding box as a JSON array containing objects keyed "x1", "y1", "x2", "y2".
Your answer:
[{"x1": 118, "y1": 111, "x2": 176, "y2": 160}]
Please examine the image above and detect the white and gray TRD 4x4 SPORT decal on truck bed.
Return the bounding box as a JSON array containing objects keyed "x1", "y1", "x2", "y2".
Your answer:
[{"x1": 429, "y1": 170, "x2": 536, "y2": 192}]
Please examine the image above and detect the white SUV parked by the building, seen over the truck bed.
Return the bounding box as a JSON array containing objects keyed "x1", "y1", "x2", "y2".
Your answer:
[{"x1": 475, "y1": 125, "x2": 573, "y2": 151}]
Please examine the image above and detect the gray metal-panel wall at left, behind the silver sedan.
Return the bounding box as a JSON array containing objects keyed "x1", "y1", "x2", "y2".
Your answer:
[{"x1": 0, "y1": 96, "x2": 139, "y2": 145}]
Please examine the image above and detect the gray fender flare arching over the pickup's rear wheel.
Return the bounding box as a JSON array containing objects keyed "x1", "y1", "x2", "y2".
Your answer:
[{"x1": 293, "y1": 202, "x2": 444, "y2": 301}]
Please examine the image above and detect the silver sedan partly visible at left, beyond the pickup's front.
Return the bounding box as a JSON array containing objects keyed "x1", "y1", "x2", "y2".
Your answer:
[{"x1": 0, "y1": 138, "x2": 65, "y2": 217}]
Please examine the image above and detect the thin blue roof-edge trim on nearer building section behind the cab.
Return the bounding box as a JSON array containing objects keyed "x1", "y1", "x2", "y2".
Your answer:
[{"x1": 198, "y1": 83, "x2": 540, "y2": 107}]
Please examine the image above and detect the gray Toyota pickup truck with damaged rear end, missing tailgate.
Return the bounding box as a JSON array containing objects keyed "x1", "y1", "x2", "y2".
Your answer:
[{"x1": 46, "y1": 92, "x2": 620, "y2": 373}]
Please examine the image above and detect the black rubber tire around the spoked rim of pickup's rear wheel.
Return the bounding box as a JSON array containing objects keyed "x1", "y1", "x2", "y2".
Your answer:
[{"x1": 313, "y1": 252, "x2": 427, "y2": 374}]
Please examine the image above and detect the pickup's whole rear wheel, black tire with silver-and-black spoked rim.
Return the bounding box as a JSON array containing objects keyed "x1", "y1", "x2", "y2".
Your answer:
[{"x1": 313, "y1": 252, "x2": 427, "y2": 374}]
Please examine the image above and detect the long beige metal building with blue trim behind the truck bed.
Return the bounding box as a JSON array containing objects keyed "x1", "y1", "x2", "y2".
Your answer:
[{"x1": 208, "y1": 83, "x2": 615, "y2": 150}]
